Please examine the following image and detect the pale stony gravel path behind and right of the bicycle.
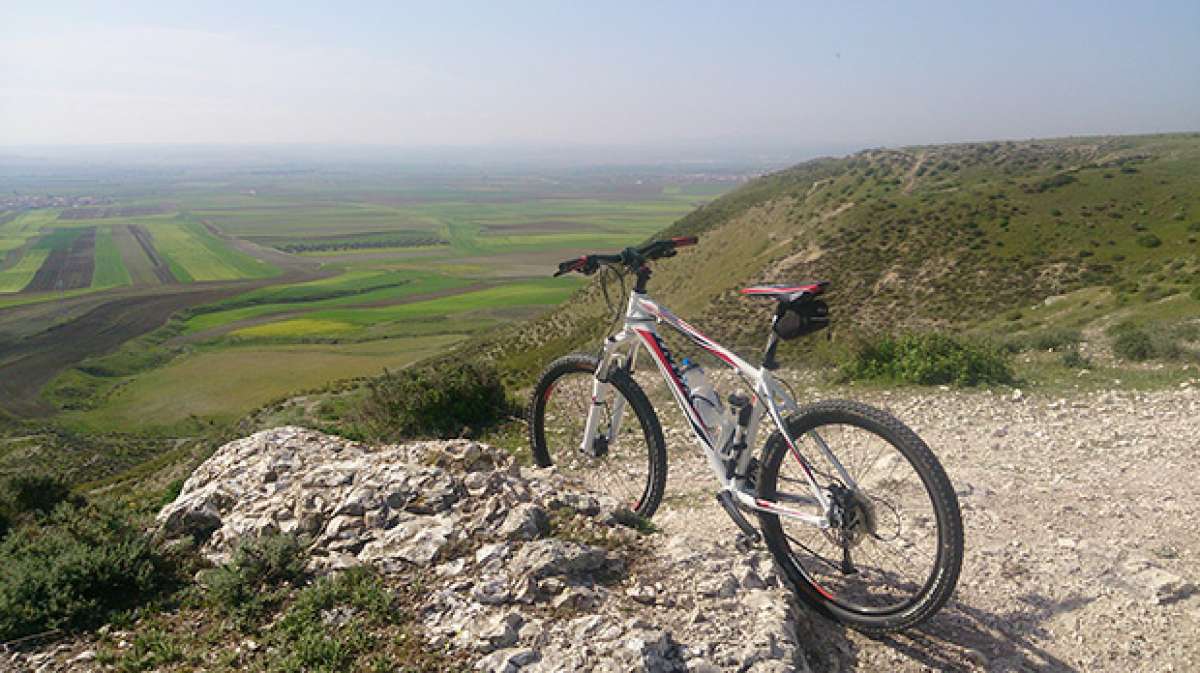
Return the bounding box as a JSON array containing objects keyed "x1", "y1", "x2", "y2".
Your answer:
[{"x1": 655, "y1": 381, "x2": 1200, "y2": 672}]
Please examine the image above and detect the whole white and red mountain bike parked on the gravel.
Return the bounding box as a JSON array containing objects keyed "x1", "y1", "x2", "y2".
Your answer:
[{"x1": 529, "y1": 236, "x2": 962, "y2": 633}]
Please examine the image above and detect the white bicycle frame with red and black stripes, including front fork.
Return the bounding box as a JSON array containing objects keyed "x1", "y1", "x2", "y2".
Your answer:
[{"x1": 580, "y1": 290, "x2": 858, "y2": 528}]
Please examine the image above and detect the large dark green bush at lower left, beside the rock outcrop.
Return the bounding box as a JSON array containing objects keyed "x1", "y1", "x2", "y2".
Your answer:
[{"x1": 0, "y1": 501, "x2": 178, "y2": 641}]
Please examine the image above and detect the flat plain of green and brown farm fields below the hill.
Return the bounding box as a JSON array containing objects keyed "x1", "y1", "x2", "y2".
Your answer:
[{"x1": 0, "y1": 161, "x2": 744, "y2": 428}]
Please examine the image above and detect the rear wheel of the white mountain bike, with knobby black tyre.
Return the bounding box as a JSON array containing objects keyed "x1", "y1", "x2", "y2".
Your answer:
[{"x1": 757, "y1": 401, "x2": 962, "y2": 633}]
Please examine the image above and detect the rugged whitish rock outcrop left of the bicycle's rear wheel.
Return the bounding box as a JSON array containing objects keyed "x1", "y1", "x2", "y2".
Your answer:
[{"x1": 158, "y1": 427, "x2": 808, "y2": 673}]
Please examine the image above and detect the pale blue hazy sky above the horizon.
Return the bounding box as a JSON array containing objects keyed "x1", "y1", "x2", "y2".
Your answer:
[{"x1": 0, "y1": 0, "x2": 1200, "y2": 146}]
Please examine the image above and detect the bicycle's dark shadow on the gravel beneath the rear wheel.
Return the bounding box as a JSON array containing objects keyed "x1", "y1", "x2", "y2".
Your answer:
[{"x1": 796, "y1": 594, "x2": 1094, "y2": 673}]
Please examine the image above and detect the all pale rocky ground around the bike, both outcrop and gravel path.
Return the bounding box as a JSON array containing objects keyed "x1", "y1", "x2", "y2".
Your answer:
[{"x1": 9, "y1": 389, "x2": 1200, "y2": 672}]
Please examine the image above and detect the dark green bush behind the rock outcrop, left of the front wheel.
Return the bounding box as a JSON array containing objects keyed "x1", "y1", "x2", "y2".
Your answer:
[{"x1": 358, "y1": 361, "x2": 511, "y2": 440}]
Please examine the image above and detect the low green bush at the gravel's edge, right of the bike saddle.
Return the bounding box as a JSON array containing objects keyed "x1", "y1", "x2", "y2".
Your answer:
[{"x1": 841, "y1": 332, "x2": 1013, "y2": 386}]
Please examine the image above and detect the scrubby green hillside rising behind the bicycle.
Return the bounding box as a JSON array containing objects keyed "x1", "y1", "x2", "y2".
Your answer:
[{"x1": 460, "y1": 133, "x2": 1200, "y2": 374}]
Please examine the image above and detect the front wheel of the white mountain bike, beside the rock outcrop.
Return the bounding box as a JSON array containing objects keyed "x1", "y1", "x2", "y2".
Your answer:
[{"x1": 529, "y1": 355, "x2": 667, "y2": 518}]
